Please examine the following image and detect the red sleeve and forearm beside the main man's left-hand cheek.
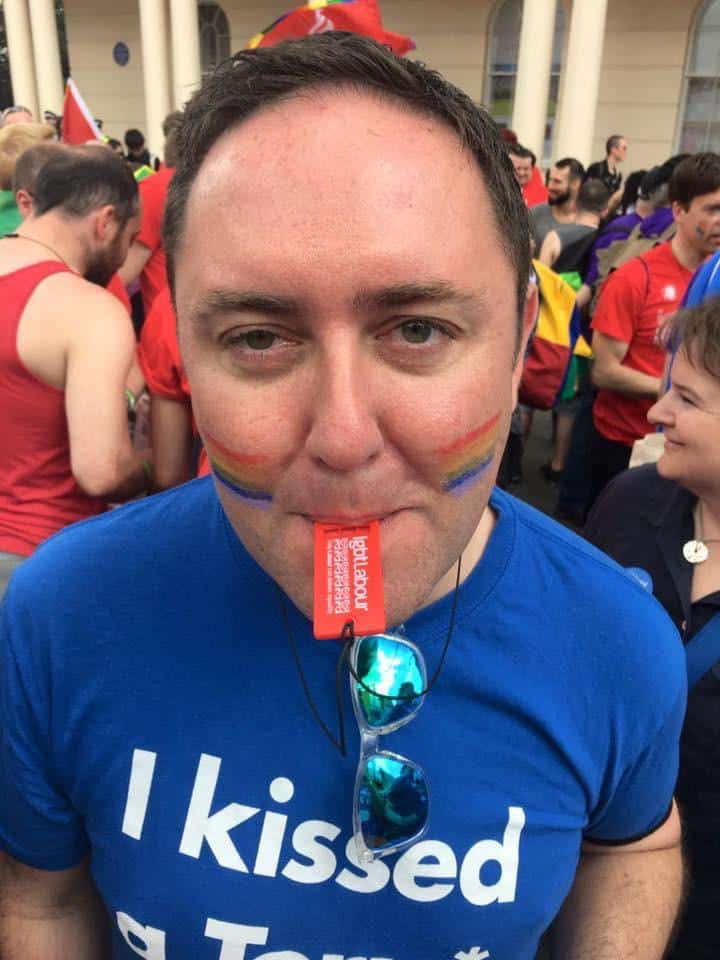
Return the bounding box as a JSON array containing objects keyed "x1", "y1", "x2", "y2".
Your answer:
[{"x1": 138, "y1": 287, "x2": 210, "y2": 490}]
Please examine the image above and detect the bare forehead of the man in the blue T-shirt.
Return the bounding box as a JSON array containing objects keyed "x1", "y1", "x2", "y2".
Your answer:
[{"x1": 176, "y1": 91, "x2": 514, "y2": 321}]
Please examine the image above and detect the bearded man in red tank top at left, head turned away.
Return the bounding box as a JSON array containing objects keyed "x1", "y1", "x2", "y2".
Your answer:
[{"x1": 0, "y1": 147, "x2": 150, "y2": 593}]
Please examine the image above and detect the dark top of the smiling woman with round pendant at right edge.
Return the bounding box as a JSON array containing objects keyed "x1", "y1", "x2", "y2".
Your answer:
[{"x1": 585, "y1": 465, "x2": 720, "y2": 960}]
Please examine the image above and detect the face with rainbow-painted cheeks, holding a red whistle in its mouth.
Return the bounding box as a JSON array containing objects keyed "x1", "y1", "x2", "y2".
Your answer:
[{"x1": 176, "y1": 93, "x2": 532, "y2": 623}]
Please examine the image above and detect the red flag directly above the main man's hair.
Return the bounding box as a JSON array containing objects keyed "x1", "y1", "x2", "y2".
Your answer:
[{"x1": 248, "y1": 0, "x2": 415, "y2": 55}]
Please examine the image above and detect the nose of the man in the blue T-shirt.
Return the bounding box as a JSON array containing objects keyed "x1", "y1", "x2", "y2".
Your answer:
[{"x1": 306, "y1": 342, "x2": 383, "y2": 472}]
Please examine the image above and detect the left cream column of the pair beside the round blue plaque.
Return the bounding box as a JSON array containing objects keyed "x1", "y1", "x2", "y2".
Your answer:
[{"x1": 140, "y1": 0, "x2": 171, "y2": 157}]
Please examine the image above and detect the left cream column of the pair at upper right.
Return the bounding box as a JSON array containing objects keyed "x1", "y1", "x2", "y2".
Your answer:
[{"x1": 512, "y1": 0, "x2": 557, "y2": 161}]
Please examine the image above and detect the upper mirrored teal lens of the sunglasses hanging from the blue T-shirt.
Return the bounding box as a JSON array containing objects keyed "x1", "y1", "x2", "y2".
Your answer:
[{"x1": 353, "y1": 635, "x2": 425, "y2": 730}]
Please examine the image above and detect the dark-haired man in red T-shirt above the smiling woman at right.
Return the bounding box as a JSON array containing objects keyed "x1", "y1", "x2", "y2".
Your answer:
[{"x1": 591, "y1": 153, "x2": 720, "y2": 500}]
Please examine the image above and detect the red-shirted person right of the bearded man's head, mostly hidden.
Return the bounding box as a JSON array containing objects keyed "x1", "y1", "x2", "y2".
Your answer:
[{"x1": 120, "y1": 111, "x2": 182, "y2": 317}]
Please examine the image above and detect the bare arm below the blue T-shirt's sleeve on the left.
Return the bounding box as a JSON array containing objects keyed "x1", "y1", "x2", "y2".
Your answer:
[{"x1": 0, "y1": 853, "x2": 110, "y2": 960}]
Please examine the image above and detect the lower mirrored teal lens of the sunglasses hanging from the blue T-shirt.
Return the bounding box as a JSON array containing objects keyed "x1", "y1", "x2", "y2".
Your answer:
[{"x1": 356, "y1": 753, "x2": 429, "y2": 853}]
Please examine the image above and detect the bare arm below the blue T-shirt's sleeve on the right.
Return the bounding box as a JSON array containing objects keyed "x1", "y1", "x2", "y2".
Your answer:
[{"x1": 551, "y1": 804, "x2": 683, "y2": 960}]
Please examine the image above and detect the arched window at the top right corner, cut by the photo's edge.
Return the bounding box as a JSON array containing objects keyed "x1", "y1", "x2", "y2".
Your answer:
[{"x1": 678, "y1": 0, "x2": 720, "y2": 153}]
